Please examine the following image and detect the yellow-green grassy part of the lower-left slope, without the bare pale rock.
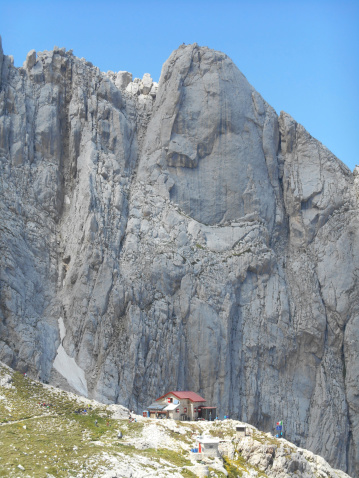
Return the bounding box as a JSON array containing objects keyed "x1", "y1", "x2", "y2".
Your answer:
[{"x1": 0, "y1": 366, "x2": 200, "y2": 478}]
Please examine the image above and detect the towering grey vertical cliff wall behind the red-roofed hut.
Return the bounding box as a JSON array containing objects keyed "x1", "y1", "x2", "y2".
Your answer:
[{"x1": 0, "y1": 40, "x2": 359, "y2": 475}]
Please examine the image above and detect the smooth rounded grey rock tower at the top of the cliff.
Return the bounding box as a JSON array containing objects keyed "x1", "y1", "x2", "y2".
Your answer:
[{"x1": 140, "y1": 46, "x2": 279, "y2": 227}]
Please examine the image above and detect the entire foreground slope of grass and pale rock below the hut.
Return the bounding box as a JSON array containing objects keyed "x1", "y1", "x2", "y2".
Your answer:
[{"x1": 0, "y1": 362, "x2": 349, "y2": 478}]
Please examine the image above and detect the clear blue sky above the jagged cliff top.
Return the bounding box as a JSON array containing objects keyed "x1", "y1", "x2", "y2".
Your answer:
[{"x1": 0, "y1": 0, "x2": 359, "y2": 170}]
